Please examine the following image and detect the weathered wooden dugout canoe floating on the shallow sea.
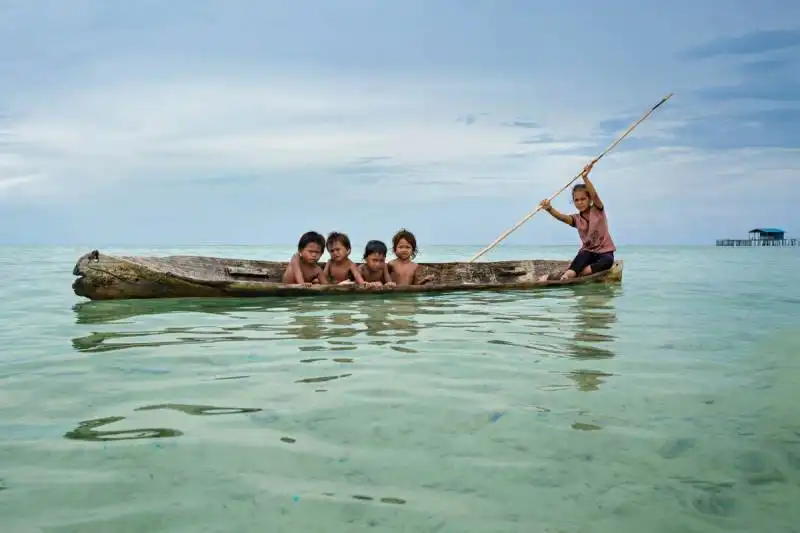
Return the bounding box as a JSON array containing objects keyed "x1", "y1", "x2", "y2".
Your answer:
[{"x1": 72, "y1": 250, "x2": 622, "y2": 300}]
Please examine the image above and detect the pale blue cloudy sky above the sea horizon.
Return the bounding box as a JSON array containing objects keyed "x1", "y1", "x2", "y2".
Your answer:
[{"x1": 0, "y1": 0, "x2": 800, "y2": 247}]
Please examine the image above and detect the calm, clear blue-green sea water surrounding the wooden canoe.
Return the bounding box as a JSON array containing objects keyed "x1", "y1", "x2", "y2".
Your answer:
[{"x1": 0, "y1": 245, "x2": 800, "y2": 533}]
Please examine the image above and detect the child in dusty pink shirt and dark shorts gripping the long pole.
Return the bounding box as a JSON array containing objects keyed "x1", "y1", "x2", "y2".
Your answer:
[{"x1": 539, "y1": 162, "x2": 617, "y2": 281}]
